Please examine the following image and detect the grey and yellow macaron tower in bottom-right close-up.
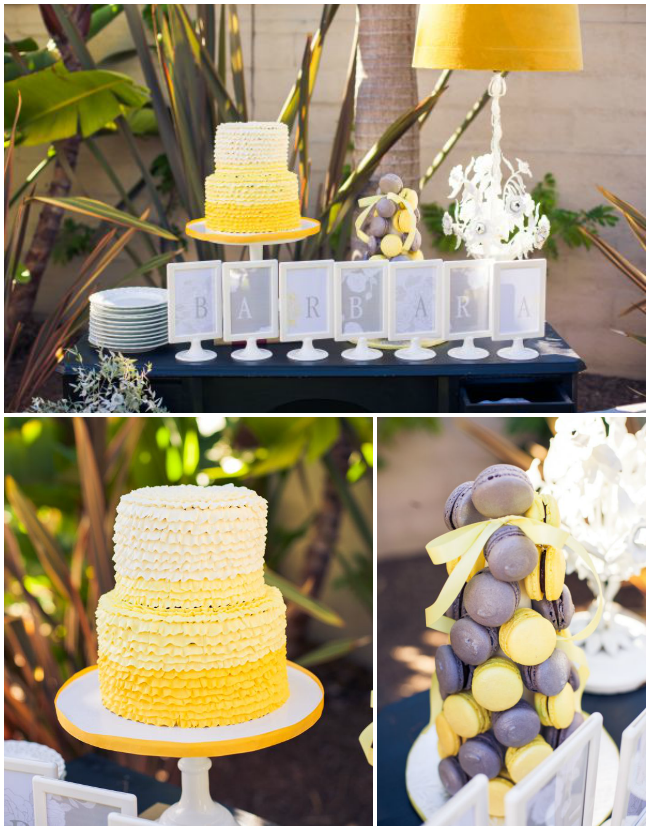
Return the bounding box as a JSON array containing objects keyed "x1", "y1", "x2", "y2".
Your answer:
[{"x1": 436, "y1": 464, "x2": 583, "y2": 817}]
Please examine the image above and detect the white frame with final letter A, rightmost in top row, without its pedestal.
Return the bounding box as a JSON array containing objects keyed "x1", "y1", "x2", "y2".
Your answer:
[{"x1": 492, "y1": 258, "x2": 546, "y2": 342}]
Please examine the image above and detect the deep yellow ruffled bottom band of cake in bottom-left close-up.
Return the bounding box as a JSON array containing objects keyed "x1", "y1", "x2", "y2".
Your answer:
[{"x1": 98, "y1": 648, "x2": 289, "y2": 727}]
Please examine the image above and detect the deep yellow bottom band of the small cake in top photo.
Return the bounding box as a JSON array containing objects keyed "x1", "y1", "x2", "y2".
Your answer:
[{"x1": 205, "y1": 200, "x2": 300, "y2": 233}]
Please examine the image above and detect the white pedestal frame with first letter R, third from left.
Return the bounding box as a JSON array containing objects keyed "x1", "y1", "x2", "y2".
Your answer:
[{"x1": 280, "y1": 259, "x2": 334, "y2": 360}]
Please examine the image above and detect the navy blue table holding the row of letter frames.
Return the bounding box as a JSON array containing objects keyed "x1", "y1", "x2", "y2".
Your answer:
[{"x1": 58, "y1": 326, "x2": 586, "y2": 415}]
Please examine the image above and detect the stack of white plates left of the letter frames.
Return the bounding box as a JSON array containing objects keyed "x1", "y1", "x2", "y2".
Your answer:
[{"x1": 89, "y1": 288, "x2": 168, "y2": 352}]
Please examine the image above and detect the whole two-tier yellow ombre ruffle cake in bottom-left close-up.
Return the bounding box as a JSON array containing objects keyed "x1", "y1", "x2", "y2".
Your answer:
[{"x1": 97, "y1": 485, "x2": 289, "y2": 726}]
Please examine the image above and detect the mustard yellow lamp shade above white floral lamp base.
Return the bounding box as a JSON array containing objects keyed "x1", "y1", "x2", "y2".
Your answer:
[{"x1": 413, "y1": 3, "x2": 582, "y2": 72}]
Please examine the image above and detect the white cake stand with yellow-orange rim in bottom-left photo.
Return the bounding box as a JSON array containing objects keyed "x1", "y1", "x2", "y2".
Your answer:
[{"x1": 54, "y1": 663, "x2": 324, "y2": 827}]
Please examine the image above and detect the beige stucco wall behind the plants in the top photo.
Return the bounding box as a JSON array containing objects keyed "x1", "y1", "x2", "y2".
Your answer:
[{"x1": 5, "y1": 3, "x2": 646, "y2": 378}]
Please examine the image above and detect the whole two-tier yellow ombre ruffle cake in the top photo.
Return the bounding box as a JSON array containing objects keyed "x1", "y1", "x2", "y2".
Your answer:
[{"x1": 205, "y1": 121, "x2": 301, "y2": 233}]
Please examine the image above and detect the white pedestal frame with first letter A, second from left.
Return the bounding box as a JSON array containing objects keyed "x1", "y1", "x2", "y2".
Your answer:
[{"x1": 221, "y1": 259, "x2": 280, "y2": 360}]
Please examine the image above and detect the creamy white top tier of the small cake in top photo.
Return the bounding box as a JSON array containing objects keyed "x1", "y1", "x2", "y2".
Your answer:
[{"x1": 214, "y1": 121, "x2": 289, "y2": 170}]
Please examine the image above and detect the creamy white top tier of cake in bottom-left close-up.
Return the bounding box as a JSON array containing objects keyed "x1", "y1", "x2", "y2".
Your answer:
[{"x1": 113, "y1": 484, "x2": 267, "y2": 582}]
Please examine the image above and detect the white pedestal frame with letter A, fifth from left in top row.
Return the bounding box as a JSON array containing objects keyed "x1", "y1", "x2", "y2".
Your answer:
[{"x1": 388, "y1": 259, "x2": 444, "y2": 360}]
